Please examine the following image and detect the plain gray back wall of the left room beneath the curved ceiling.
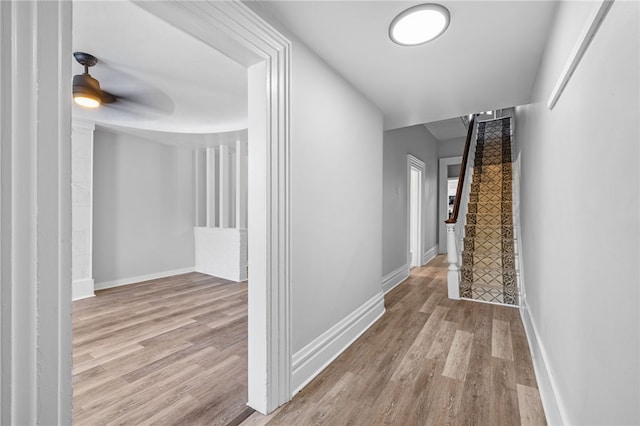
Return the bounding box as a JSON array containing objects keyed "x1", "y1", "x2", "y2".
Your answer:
[{"x1": 93, "y1": 127, "x2": 195, "y2": 285}]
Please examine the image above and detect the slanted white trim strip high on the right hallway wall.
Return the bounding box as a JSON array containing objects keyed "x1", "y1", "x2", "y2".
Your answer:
[{"x1": 547, "y1": 0, "x2": 614, "y2": 109}]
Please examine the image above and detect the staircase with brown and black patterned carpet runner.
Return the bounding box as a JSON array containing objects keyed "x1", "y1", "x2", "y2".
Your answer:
[{"x1": 460, "y1": 117, "x2": 519, "y2": 306}]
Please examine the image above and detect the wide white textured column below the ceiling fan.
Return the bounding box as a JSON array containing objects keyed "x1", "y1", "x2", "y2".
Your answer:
[{"x1": 71, "y1": 119, "x2": 95, "y2": 300}]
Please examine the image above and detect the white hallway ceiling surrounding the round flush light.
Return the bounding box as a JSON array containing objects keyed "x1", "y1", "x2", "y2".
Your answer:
[{"x1": 261, "y1": 0, "x2": 556, "y2": 129}]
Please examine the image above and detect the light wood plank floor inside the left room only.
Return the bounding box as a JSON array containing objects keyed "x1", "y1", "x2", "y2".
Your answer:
[{"x1": 73, "y1": 272, "x2": 254, "y2": 425}]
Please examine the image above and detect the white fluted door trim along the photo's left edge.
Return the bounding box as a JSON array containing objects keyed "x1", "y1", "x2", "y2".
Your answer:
[{"x1": 0, "y1": 0, "x2": 73, "y2": 425}]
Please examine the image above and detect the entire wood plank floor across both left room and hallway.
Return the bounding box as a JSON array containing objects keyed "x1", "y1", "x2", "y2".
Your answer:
[{"x1": 73, "y1": 256, "x2": 545, "y2": 426}]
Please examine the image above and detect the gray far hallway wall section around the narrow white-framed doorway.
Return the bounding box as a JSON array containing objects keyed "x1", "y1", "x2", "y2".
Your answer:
[{"x1": 382, "y1": 125, "x2": 438, "y2": 276}]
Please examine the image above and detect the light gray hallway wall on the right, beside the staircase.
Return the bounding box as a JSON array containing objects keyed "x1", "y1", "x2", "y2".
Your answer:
[{"x1": 515, "y1": 2, "x2": 640, "y2": 425}]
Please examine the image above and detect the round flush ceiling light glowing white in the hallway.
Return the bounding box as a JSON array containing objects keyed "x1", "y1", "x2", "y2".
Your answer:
[{"x1": 389, "y1": 3, "x2": 450, "y2": 46}]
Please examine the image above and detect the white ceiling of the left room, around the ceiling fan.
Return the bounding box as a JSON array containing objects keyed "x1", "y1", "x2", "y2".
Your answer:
[{"x1": 69, "y1": 1, "x2": 247, "y2": 133}]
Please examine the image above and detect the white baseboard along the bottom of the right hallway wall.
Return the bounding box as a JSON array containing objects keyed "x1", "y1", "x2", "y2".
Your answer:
[{"x1": 520, "y1": 299, "x2": 569, "y2": 426}]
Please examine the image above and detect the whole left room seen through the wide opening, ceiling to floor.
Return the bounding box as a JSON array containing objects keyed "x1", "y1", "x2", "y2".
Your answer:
[{"x1": 72, "y1": 2, "x2": 253, "y2": 425}]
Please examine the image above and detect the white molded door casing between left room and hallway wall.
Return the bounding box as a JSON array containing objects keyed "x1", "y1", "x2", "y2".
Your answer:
[{"x1": 134, "y1": 0, "x2": 292, "y2": 414}]
